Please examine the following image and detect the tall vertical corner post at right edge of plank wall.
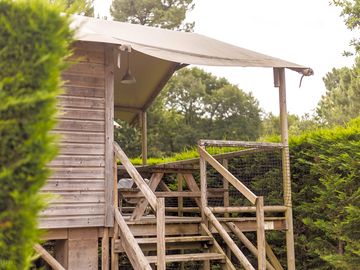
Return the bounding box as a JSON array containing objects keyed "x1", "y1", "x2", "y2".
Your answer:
[{"x1": 105, "y1": 44, "x2": 114, "y2": 227}]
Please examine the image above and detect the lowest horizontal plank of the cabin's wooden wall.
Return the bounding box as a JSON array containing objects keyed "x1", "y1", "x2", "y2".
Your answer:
[{"x1": 39, "y1": 215, "x2": 104, "y2": 229}]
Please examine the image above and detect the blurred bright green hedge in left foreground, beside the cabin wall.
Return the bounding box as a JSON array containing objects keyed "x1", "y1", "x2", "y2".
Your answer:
[{"x1": 0, "y1": 0, "x2": 72, "y2": 269}]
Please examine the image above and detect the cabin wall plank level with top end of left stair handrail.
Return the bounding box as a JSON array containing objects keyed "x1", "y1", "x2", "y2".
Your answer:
[{"x1": 59, "y1": 143, "x2": 105, "y2": 155}]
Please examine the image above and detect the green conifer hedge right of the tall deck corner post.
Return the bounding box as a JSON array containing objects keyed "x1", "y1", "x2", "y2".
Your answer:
[{"x1": 290, "y1": 118, "x2": 360, "y2": 269}]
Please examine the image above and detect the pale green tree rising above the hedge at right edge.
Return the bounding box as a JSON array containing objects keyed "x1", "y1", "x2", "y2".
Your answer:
[{"x1": 316, "y1": 57, "x2": 360, "y2": 125}]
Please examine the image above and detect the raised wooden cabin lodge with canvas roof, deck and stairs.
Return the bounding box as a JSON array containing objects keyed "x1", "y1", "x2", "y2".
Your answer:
[{"x1": 35, "y1": 16, "x2": 312, "y2": 270}]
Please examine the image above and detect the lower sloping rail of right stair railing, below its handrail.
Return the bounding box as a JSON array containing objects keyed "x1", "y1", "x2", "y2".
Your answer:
[{"x1": 204, "y1": 207, "x2": 255, "y2": 270}]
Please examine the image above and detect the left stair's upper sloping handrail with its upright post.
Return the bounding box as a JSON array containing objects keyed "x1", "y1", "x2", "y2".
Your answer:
[{"x1": 114, "y1": 142, "x2": 166, "y2": 270}]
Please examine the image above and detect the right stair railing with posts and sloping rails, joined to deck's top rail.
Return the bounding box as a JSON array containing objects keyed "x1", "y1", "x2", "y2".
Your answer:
[{"x1": 198, "y1": 140, "x2": 285, "y2": 270}]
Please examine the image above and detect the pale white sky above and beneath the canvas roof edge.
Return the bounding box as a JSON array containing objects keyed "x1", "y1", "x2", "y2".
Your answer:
[{"x1": 95, "y1": 0, "x2": 354, "y2": 115}]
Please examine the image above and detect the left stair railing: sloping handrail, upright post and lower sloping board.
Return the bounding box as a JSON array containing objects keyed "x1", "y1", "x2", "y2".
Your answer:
[{"x1": 114, "y1": 143, "x2": 166, "y2": 270}]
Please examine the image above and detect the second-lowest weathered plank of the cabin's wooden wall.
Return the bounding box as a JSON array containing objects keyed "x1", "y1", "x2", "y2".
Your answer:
[{"x1": 40, "y1": 203, "x2": 105, "y2": 217}]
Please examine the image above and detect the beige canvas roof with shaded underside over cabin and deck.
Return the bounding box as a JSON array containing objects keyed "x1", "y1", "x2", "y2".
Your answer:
[{"x1": 72, "y1": 15, "x2": 312, "y2": 122}]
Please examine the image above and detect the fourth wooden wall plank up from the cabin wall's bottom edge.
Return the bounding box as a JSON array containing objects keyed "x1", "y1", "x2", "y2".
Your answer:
[{"x1": 41, "y1": 179, "x2": 105, "y2": 191}]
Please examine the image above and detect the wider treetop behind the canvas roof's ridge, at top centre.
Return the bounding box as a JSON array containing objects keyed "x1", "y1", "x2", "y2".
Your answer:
[{"x1": 110, "y1": 0, "x2": 194, "y2": 31}]
